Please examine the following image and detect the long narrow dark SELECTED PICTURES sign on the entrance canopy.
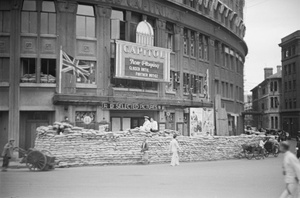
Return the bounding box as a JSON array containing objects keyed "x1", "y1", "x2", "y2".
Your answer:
[{"x1": 102, "y1": 103, "x2": 162, "y2": 111}]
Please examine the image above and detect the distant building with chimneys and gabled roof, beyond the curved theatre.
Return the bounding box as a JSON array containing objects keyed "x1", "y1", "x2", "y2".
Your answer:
[{"x1": 251, "y1": 66, "x2": 282, "y2": 130}]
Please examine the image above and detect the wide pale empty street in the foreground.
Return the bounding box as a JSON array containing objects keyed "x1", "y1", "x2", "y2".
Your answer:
[{"x1": 0, "y1": 155, "x2": 284, "y2": 198}]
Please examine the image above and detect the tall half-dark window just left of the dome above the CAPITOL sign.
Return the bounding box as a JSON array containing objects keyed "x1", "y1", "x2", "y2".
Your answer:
[{"x1": 110, "y1": 10, "x2": 125, "y2": 40}]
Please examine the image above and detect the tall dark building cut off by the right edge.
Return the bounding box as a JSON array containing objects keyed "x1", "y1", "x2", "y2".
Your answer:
[{"x1": 279, "y1": 30, "x2": 300, "y2": 137}]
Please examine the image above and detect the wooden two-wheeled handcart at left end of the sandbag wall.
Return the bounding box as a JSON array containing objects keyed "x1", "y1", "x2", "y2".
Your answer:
[{"x1": 16, "y1": 148, "x2": 59, "y2": 171}]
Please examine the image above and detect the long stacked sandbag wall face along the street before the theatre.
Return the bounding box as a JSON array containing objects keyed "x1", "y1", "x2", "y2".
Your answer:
[{"x1": 35, "y1": 131, "x2": 263, "y2": 167}]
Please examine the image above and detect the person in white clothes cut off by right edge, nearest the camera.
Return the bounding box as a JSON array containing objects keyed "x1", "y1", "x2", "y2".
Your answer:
[{"x1": 280, "y1": 141, "x2": 300, "y2": 198}]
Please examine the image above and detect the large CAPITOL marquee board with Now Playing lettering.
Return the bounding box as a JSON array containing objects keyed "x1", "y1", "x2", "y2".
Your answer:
[{"x1": 115, "y1": 40, "x2": 171, "y2": 82}]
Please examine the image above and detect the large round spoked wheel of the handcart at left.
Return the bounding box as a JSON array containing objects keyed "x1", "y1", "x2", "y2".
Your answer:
[{"x1": 26, "y1": 151, "x2": 47, "y2": 171}]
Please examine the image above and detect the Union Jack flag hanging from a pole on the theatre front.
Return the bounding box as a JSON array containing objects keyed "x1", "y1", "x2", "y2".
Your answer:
[{"x1": 61, "y1": 50, "x2": 91, "y2": 80}]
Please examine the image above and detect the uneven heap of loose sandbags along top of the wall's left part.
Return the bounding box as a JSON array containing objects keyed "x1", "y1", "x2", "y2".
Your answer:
[{"x1": 36, "y1": 122, "x2": 181, "y2": 139}]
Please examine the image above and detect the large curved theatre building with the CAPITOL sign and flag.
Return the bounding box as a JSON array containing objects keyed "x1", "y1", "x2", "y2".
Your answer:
[{"x1": 0, "y1": 0, "x2": 248, "y2": 148}]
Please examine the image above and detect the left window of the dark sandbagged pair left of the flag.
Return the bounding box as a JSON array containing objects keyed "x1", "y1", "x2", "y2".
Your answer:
[{"x1": 21, "y1": 58, "x2": 36, "y2": 83}]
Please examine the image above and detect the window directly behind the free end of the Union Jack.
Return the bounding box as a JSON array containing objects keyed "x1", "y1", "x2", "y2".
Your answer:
[{"x1": 77, "y1": 60, "x2": 97, "y2": 84}]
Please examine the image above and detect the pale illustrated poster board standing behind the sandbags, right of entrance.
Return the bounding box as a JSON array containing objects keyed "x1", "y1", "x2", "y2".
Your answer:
[{"x1": 190, "y1": 108, "x2": 214, "y2": 136}]
